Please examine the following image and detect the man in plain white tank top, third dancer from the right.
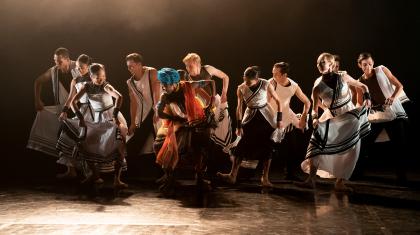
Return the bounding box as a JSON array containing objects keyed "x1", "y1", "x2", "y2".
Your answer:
[{"x1": 269, "y1": 62, "x2": 311, "y2": 179}]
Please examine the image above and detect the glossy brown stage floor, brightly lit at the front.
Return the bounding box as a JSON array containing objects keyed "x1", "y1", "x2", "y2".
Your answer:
[{"x1": 0, "y1": 180, "x2": 420, "y2": 235}]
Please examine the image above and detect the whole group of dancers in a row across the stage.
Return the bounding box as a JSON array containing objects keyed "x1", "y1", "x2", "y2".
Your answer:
[{"x1": 27, "y1": 48, "x2": 408, "y2": 193}]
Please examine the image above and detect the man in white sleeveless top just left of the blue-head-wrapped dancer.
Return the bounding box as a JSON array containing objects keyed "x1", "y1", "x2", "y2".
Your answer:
[{"x1": 126, "y1": 53, "x2": 161, "y2": 157}]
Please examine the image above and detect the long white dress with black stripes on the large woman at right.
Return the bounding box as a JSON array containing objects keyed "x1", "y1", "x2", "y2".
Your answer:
[{"x1": 301, "y1": 74, "x2": 370, "y2": 179}]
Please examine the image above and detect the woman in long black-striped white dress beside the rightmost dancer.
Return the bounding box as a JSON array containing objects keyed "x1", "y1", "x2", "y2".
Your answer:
[{"x1": 299, "y1": 53, "x2": 370, "y2": 191}]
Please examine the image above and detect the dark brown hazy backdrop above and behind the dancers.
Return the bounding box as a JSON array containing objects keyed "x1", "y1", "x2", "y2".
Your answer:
[{"x1": 0, "y1": 0, "x2": 420, "y2": 180}]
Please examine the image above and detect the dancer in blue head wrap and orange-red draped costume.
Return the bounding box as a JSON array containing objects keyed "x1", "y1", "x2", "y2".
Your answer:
[{"x1": 154, "y1": 68, "x2": 215, "y2": 194}]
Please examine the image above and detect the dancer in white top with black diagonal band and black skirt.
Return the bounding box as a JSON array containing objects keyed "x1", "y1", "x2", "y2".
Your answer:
[{"x1": 217, "y1": 66, "x2": 283, "y2": 187}]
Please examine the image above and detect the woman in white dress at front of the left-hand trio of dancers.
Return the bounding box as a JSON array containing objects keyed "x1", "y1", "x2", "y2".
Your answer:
[{"x1": 71, "y1": 63, "x2": 128, "y2": 188}]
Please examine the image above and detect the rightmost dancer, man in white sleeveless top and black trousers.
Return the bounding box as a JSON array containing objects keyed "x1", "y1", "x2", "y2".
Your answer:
[{"x1": 357, "y1": 53, "x2": 409, "y2": 184}]
